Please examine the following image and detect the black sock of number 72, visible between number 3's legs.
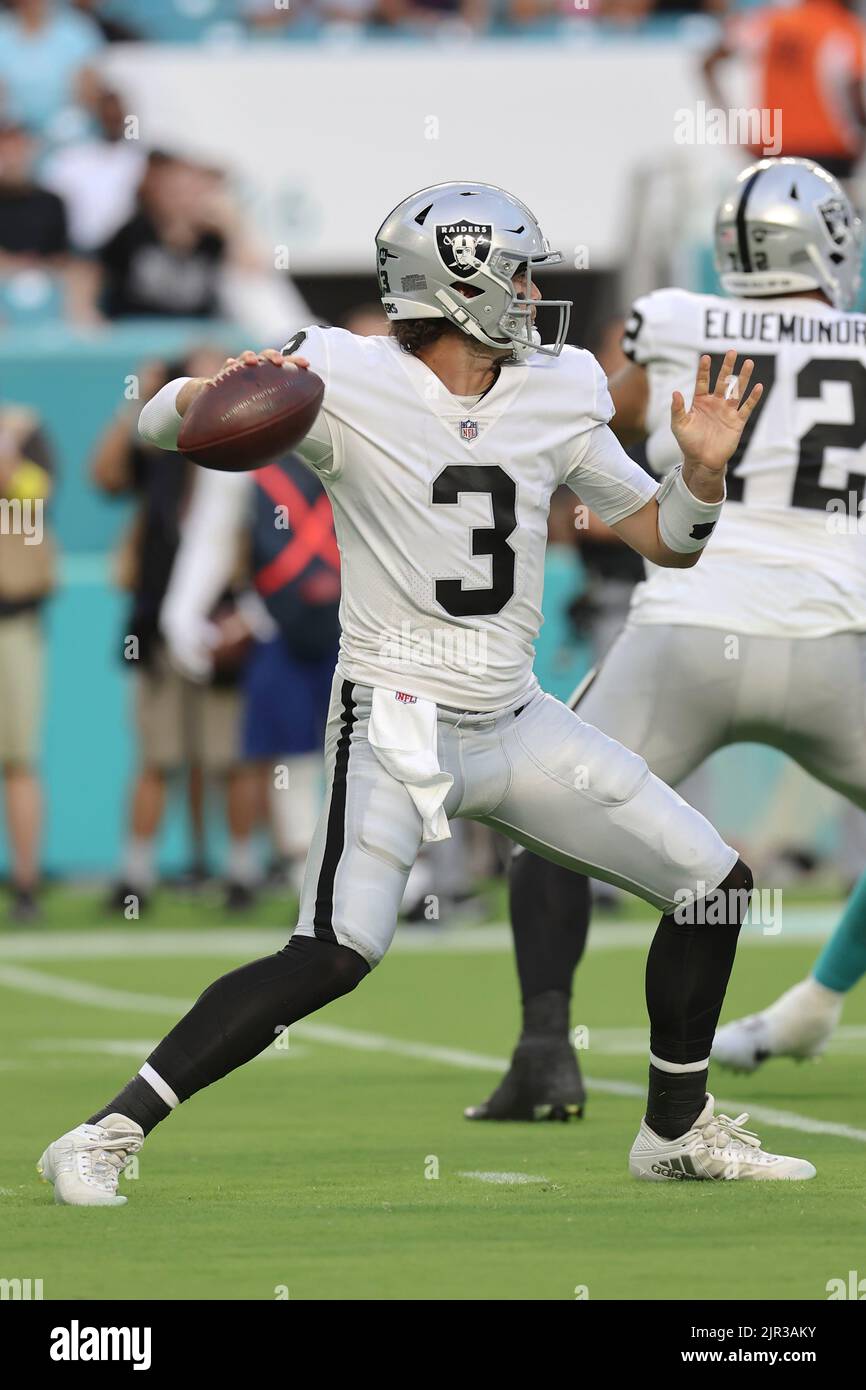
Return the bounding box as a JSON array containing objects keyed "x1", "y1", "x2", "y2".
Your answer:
[{"x1": 509, "y1": 851, "x2": 589, "y2": 1037}]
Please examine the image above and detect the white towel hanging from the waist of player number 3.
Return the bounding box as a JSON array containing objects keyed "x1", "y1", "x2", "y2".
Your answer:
[{"x1": 367, "y1": 687, "x2": 455, "y2": 841}]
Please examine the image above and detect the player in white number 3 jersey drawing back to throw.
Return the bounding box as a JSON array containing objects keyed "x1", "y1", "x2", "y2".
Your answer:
[{"x1": 40, "y1": 183, "x2": 815, "y2": 1204}]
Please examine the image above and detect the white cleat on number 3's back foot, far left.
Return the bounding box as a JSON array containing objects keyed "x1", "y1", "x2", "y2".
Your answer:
[{"x1": 36, "y1": 1115, "x2": 145, "y2": 1207}]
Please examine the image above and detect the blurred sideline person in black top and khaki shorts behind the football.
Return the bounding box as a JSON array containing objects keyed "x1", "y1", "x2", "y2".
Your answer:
[{"x1": 92, "y1": 349, "x2": 259, "y2": 912}]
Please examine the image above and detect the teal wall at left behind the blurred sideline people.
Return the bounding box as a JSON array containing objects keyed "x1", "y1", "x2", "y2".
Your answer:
[{"x1": 0, "y1": 321, "x2": 237, "y2": 876}]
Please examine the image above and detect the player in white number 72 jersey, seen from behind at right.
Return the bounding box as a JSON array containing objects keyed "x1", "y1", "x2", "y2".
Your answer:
[{"x1": 466, "y1": 158, "x2": 866, "y2": 1119}]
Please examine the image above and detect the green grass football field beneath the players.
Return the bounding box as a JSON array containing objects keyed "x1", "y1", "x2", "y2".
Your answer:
[{"x1": 0, "y1": 892, "x2": 866, "y2": 1300}]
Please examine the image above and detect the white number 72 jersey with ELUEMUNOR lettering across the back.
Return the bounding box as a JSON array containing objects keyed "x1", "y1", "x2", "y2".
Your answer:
[{"x1": 624, "y1": 289, "x2": 866, "y2": 637}]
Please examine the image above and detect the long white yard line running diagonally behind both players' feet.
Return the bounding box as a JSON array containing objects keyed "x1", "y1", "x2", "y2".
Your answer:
[{"x1": 0, "y1": 966, "x2": 866, "y2": 1144}]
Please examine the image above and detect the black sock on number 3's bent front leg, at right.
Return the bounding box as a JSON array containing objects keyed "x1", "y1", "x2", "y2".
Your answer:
[{"x1": 646, "y1": 859, "x2": 752, "y2": 1138}]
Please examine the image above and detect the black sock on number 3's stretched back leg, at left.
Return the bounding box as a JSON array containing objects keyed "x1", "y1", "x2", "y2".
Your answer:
[{"x1": 89, "y1": 935, "x2": 370, "y2": 1133}]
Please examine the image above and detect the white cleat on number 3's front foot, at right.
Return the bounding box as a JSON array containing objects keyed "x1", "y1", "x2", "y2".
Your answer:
[{"x1": 628, "y1": 1095, "x2": 815, "y2": 1183}]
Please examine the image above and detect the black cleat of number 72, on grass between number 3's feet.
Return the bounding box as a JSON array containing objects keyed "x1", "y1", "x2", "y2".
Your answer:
[{"x1": 463, "y1": 1037, "x2": 587, "y2": 1120}]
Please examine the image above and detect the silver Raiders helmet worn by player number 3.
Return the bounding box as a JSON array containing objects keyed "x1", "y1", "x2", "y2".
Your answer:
[{"x1": 375, "y1": 183, "x2": 571, "y2": 359}]
